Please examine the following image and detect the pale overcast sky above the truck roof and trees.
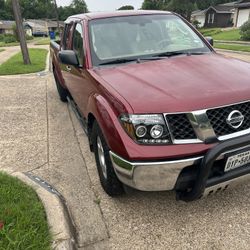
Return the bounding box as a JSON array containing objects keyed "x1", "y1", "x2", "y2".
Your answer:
[{"x1": 57, "y1": 0, "x2": 143, "y2": 11}]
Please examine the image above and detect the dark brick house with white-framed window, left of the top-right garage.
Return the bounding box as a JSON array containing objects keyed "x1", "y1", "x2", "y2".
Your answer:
[{"x1": 204, "y1": 2, "x2": 236, "y2": 28}]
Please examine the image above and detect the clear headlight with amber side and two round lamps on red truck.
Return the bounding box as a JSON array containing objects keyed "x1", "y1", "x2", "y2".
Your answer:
[{"x1": 120, "y1": 114, "x2": 171, "y2": 145}]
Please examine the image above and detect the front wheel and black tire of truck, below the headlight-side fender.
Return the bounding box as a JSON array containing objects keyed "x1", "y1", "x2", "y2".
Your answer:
[{"x1": 92, "y1": 121, "x2": 124, "y2": 197}]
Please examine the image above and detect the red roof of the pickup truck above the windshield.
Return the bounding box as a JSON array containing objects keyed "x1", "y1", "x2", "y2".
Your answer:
[{"x1": 65, "y1": 10, "x2": 171, "y2": 23}]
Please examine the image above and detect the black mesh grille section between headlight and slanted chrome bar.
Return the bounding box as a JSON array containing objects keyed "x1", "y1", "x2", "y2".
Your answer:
[{"x1": 166, "y1": 114, "x2": 197, "y2": 140}]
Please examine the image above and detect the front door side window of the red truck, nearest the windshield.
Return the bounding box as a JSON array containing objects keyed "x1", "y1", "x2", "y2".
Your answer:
[{"x1": 73, "y1": 23, "x2": 84, "y2": 64}]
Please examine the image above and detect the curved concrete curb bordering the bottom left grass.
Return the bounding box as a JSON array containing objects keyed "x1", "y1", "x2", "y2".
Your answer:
[{"x1": 1, "y1": 169, "x2": 76, "y2": 250}]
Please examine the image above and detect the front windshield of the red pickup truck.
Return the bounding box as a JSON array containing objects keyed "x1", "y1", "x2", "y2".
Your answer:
[{"x1": 90, "y1": 14, "x2": 211, "y2": 66}]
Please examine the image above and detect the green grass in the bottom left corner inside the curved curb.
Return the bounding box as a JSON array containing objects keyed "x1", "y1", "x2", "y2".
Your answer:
[{"x1": 0, "y1": 173, "x2": 52, "y2": 250}]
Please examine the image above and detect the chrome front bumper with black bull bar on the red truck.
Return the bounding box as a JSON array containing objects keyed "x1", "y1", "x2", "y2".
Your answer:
[{"x1": 110, "y1": 135, "x2": 250, "y2": 201}]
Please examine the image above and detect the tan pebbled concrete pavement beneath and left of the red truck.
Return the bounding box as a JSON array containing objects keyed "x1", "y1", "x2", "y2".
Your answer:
[{"x1": 0, "y1": 51, "x2": 250, "y2": 250}]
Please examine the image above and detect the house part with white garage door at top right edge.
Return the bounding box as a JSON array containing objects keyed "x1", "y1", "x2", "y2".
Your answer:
[{"x1": 234, "y1": 0, "x2": 250, "y2": 27}]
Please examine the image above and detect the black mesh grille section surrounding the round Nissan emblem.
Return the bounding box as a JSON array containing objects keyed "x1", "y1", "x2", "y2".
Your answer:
[{"x1": 207, "y1": 102, "x2": 250, "y2": 136}]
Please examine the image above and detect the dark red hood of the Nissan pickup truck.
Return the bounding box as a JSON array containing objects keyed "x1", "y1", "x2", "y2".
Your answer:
[{"x1": 94, "y1": 53, "x2": 250, "y2": 113}]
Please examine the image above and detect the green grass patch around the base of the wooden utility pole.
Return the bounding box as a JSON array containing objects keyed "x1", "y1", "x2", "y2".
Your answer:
[{"x1": 0, "y1": 49, "x2": 48, "y2": 75}]
